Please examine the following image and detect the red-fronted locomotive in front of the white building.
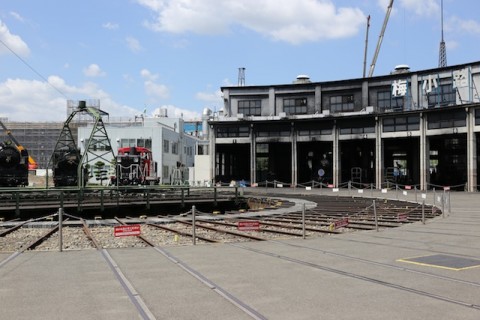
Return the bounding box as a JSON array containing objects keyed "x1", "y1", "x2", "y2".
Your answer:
[{"x1": 110, "y1": 147, "x2": 159, "y2": 185}]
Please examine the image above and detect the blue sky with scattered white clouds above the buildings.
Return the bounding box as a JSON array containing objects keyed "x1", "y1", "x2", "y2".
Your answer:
[{"x1": 0, "y1": 0, "x2": 480, "y2": 122}]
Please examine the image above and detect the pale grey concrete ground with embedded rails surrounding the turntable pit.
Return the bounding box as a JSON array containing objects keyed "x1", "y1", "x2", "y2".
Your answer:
[{"x1": 0, "y1": 189, "x2": 480, "y2": 320}]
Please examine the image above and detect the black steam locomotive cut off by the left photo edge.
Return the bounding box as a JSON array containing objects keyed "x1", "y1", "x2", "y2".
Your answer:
[{"x1": 0, "y1": 142, "x2": 28, "y2": 187}]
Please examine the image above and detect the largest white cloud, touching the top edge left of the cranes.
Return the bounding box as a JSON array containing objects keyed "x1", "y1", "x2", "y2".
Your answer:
[{"x1": 137, "y1": 0, "x2": 365, "y2": 44}]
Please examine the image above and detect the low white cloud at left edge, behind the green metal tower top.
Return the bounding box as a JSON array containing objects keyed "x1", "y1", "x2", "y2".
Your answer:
[{"x1": 0, "y1": 76, "x2": 140, "y2": 122}]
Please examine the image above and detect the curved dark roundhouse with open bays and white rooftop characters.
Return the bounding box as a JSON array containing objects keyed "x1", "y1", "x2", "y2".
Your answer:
[{"x1": 209, "y1": 62, "x2": 480, "y2": 191}]
